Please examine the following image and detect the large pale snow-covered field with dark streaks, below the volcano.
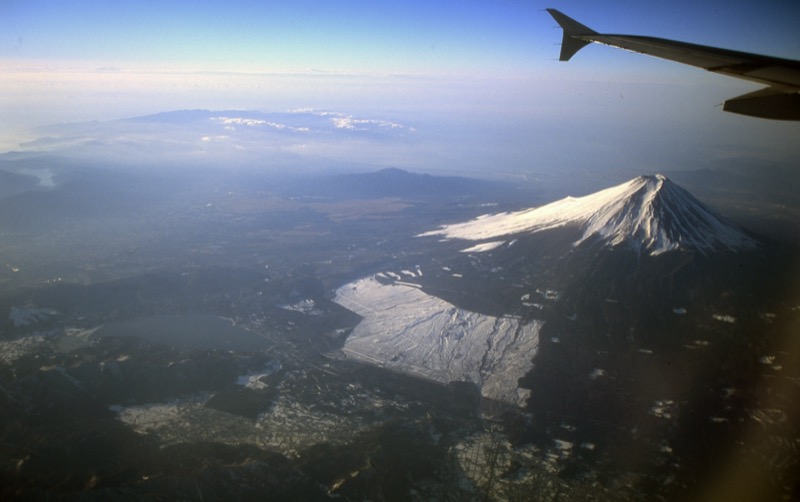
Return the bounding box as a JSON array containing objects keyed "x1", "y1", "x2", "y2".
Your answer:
[{"x1": 334, "y1": 276, "x2": 543, "y2": 406}]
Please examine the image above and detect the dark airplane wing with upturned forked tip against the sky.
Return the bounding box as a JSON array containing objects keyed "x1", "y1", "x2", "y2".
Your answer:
[{"x1": 547, "y1": 9, "x2": 800, "y2": 120}]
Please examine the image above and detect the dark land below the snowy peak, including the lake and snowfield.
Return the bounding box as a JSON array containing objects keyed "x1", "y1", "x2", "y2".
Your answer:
[{"x1": 0, "y1": 165, "x2": 800, "y2": 500}]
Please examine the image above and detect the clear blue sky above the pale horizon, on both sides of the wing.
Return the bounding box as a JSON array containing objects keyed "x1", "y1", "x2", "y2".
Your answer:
[{"x1": 0, "y1": 0, "x2": 800, "y2": 73}]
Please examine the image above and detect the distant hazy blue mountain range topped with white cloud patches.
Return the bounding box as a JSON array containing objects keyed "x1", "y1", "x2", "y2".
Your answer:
[{"x1": 10, "y1": 109, "x2": 417, "y2": 175}]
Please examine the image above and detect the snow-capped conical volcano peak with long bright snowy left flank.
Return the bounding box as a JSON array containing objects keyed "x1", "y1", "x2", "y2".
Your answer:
[{"x1": 420, "y1": 174, "x2": 756, "y2": 255}]
